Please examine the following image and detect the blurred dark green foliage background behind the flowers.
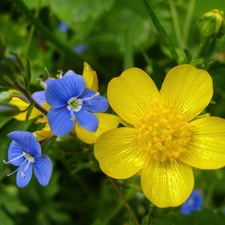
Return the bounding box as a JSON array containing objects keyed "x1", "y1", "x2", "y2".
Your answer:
[{"x1": 0, "y1": 0, "x2": 225, "y2": 225}]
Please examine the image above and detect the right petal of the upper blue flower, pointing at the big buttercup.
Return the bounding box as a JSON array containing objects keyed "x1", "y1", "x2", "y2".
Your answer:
[{"x1": 83, "y1": 96, "x2": 109, "y2": 112}]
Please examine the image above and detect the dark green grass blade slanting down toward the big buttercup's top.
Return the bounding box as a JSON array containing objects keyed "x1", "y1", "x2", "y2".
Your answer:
[{"x1": 143, "y1": 0, "x2": 178, "y2": 62}]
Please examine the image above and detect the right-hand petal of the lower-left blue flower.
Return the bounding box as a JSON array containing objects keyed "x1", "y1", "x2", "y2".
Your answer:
[{"x1": 34, "y1": 155, "x2": 52, "y2": 186}]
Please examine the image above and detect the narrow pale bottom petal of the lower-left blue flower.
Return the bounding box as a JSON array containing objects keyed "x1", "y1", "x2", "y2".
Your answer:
[{"x1": 16, "y1": 161, "x2": 33, "y2": 188}]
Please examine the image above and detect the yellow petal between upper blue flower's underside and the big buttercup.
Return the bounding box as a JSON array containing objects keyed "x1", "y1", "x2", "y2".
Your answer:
[{"x1": 75, "y1": 113, "x2": 119, "y2": 144}]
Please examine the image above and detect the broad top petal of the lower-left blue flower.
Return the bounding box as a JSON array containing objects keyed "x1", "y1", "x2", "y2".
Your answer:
[{"x1": 8, "y1": 131, "x2": 41, "y2": 157}]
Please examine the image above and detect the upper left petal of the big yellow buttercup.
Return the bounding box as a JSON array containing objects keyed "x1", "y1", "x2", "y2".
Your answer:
[{"x1": 108, "y1": 68, "x2": 159, "y2": 124}]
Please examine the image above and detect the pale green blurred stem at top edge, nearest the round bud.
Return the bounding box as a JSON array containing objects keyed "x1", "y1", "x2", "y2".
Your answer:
[{"x1": 183, "y1": 0, "x2": 195, "y2": 48}]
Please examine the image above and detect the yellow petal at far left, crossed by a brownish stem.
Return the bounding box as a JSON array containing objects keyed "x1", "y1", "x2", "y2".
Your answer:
[{"x1": 9, "y1": 98, "x2": 42, "y2": 121}]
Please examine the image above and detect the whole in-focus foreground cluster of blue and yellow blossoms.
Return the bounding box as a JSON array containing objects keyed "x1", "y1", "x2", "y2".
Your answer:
[{"x1": 2, "y1": 63, "x2": 225, "y2": 211}]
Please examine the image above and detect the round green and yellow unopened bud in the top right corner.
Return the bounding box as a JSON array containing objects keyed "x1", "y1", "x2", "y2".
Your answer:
[{"x1": 196, "y1": 9, "x2": 225, "y2": 38}]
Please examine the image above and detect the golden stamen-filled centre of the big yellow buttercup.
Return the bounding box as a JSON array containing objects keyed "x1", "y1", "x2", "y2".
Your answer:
[{"x1": 134, "y1": 104, "x2": 191, "y2": 162}]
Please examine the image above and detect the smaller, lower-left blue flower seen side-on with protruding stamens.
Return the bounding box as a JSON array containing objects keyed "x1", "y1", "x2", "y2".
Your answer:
[{"x1": 4, "y1": 131, "x2": 52, "y2": 188}]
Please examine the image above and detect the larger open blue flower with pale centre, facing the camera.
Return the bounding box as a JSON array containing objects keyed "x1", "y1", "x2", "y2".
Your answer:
[{"x1": 45, "y1": 75, "x2": 108, "y2": 136}]
